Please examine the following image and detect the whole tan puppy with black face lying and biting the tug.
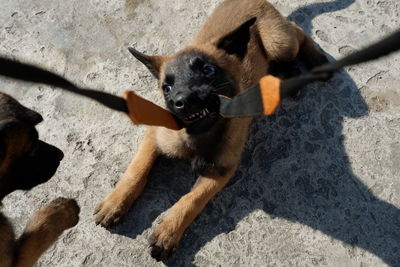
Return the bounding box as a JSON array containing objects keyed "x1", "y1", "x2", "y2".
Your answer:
[{"x1": 95, "y1": 0, "x2": 326, "y2": 260}]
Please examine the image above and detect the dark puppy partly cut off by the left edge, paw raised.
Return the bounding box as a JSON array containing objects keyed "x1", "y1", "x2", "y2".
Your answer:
[{"x1": 0, "y1": 93, "x2": 79, "y2": 267}]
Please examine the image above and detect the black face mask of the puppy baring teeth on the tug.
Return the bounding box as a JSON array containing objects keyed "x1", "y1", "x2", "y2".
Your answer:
[{"x1": 161, "y1": 51, "x2": 235, "y2": 134}]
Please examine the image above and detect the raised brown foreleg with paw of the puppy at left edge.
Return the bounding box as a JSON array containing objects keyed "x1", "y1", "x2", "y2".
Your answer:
[{"x1": 13, "y1": 198, "x2": 79, "y2": 267}]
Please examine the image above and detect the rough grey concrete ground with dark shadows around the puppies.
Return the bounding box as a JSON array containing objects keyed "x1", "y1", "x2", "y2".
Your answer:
[{"x1": 0, "y1": 0, "x2": 400, "y2": 266}]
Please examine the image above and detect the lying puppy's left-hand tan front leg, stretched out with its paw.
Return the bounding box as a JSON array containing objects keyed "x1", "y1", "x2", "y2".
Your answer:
[{"x1": 95, "y1": 128, "x2": 159, "y2": 227}]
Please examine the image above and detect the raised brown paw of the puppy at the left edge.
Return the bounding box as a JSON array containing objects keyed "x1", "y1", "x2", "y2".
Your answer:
[{"x1": 27, "y1": 198, "x2": 80, "y2": 231}]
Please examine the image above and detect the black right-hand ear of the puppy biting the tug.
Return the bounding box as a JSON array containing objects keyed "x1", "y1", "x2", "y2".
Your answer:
[{"x1": 217, "y1": 17, "x2": 257, "y2": 59}]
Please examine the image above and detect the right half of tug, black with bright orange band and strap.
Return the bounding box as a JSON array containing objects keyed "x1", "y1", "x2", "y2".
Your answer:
[{"x1": 220, "y1": 31, "x2": 400, "y2": 117}]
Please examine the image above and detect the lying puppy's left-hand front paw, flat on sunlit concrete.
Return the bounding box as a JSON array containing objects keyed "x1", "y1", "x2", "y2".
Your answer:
[{"x1": 94, "y1": 193, "x2": 129, "y2": 227}]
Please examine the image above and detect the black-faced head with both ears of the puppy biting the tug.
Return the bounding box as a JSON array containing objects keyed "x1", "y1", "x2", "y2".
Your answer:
[{"x1": 129, "y1": 18, "x2": 256, "y2": 134}]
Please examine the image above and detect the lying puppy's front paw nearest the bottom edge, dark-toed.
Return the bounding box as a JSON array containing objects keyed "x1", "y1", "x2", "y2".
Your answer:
[{"x1": 149, "y1": 221, "x2": 183, "y2": 261}]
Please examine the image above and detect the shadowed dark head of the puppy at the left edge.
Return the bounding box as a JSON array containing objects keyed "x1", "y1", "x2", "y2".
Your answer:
[{"x1": 0, "y1": 93, "x2": 63, "y2": 200}]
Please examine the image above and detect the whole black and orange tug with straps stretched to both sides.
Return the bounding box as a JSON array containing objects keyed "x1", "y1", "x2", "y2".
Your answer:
[{"x1": 0, "y1": 31, "x2": 400, "y2": 130}]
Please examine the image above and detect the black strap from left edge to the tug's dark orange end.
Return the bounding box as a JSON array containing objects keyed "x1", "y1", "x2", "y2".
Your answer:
[{"x1": 0, "y1": 57, "x2": 128, "y2": 112}]
